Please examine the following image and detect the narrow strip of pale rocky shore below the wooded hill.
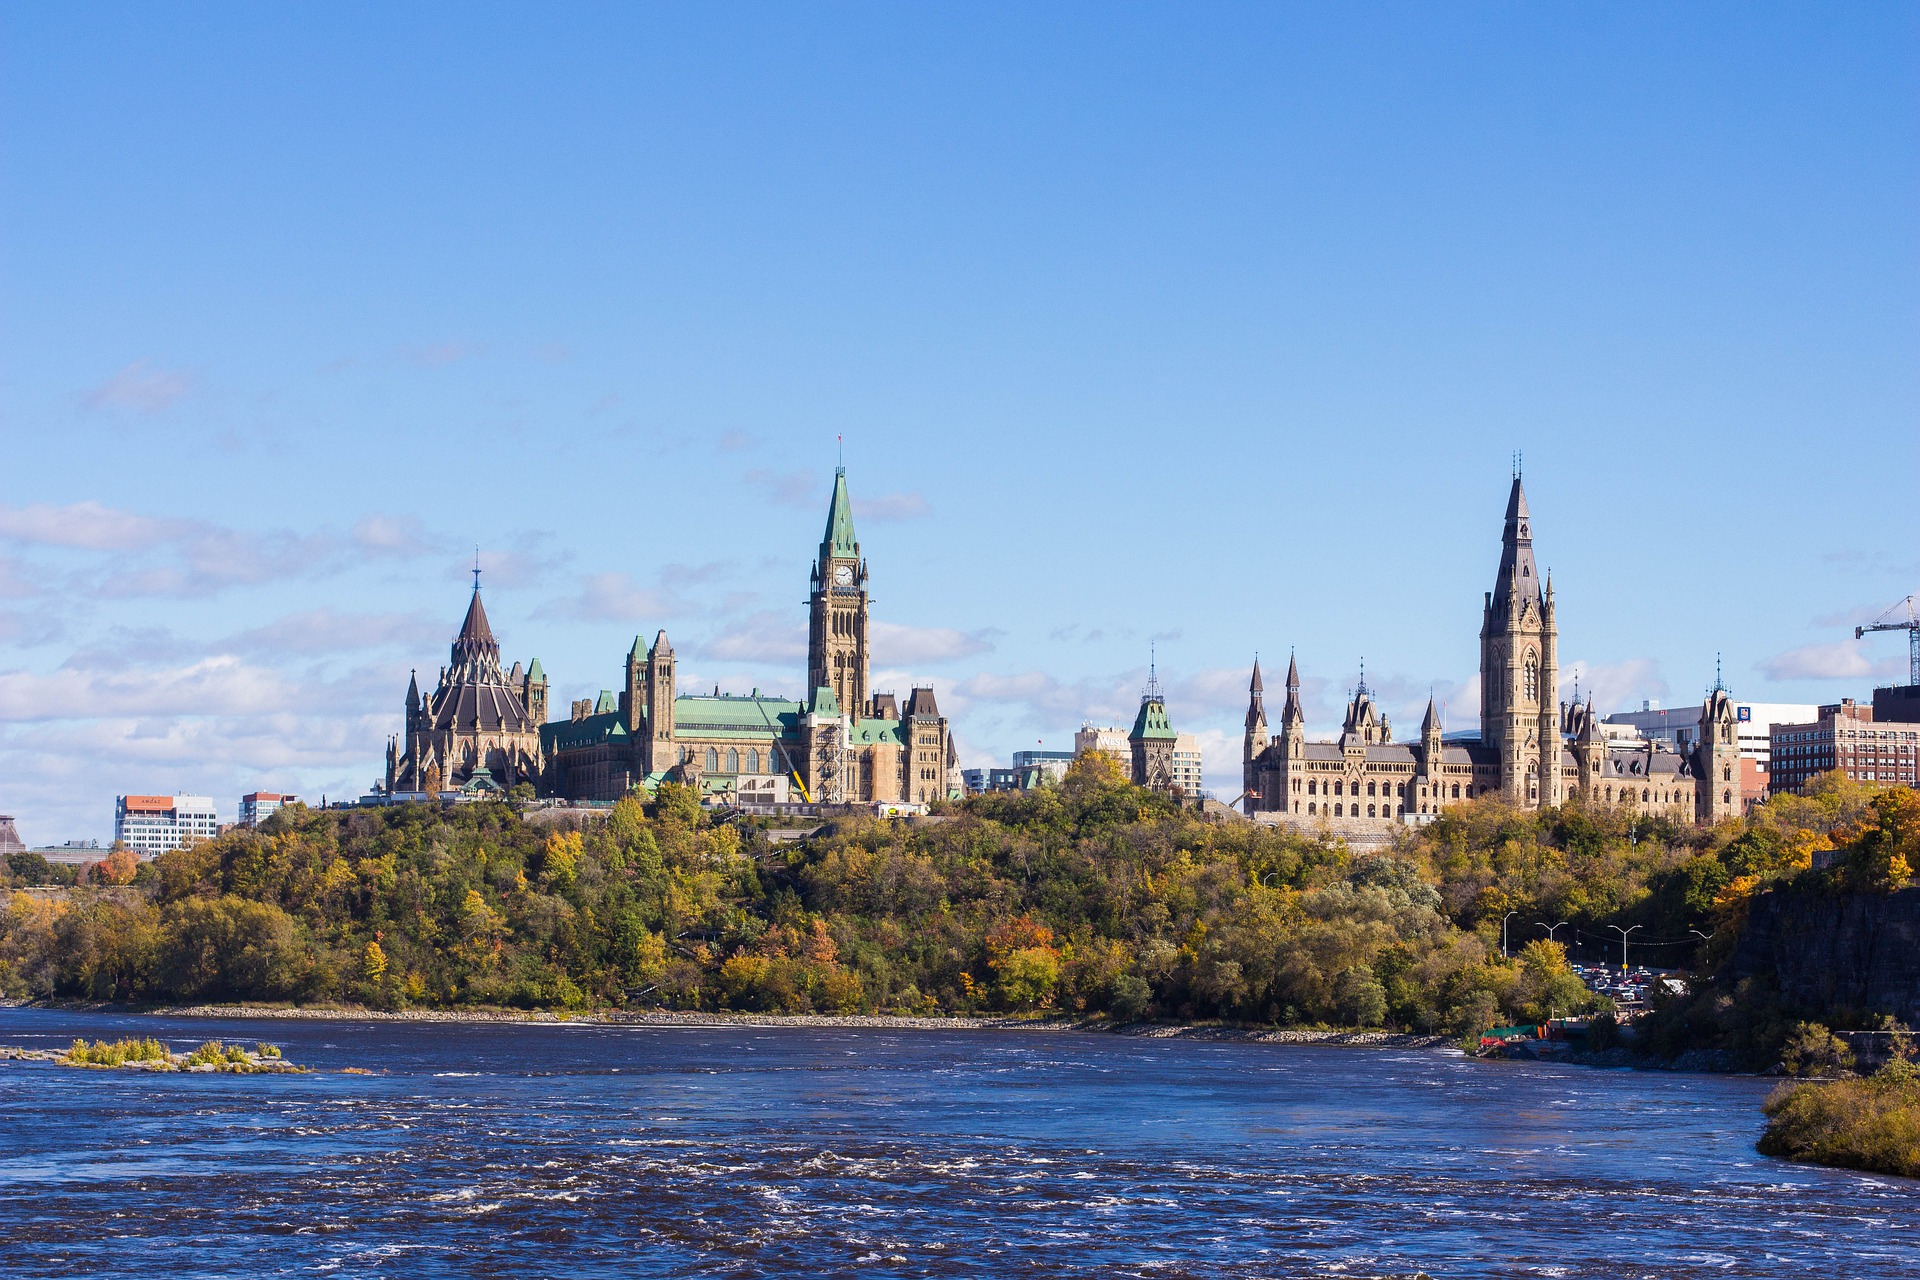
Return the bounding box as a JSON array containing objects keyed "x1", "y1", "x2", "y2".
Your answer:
[{"x1": 0, "y1": 1000, "x2": 1453, "y2": 1048}]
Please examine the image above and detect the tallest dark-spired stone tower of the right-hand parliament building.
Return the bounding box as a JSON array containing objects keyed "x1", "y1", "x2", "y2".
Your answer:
[{"x1": 1480, "y1": 472, "x2": 1561, "y2": 808}]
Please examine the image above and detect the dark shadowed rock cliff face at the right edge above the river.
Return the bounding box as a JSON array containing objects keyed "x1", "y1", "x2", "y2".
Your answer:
[{"x1": 1722, "y1": 889, "x2": 1920, "y2": 1025}]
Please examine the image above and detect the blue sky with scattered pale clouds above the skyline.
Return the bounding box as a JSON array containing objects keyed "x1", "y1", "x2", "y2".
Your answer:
[{"x1": 0, "y1": 4, "x2": 1920, "y2": 842}]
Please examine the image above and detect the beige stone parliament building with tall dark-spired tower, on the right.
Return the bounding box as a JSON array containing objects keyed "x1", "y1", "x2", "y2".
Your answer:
[{"x1": 1242, "y1": 476, "x2": 1741, "y2": 833}]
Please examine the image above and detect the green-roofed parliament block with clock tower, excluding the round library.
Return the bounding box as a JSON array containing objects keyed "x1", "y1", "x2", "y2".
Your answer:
[{"x1": 543, "y1": 468, "x2": 960, "y2": 804}]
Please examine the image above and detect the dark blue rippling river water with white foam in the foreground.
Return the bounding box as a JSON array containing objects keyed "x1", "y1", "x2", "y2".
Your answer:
[{"x1": 0, "y1": 1009, "x2": 1920, "y2": 1280}]
